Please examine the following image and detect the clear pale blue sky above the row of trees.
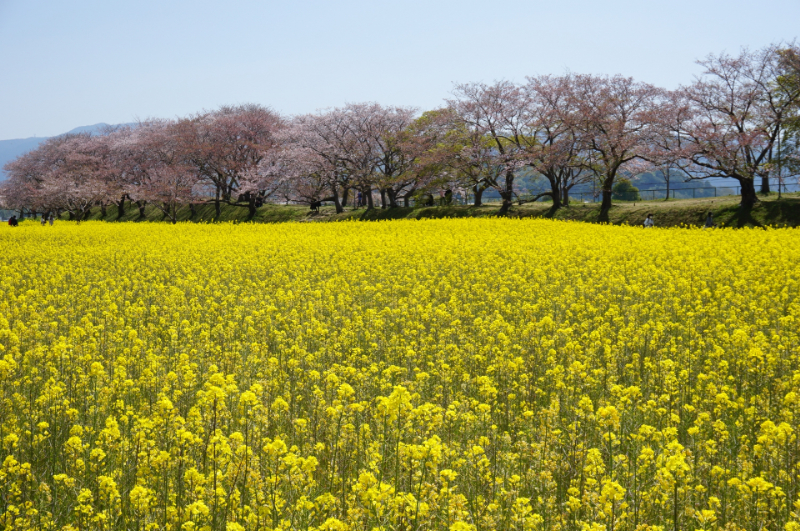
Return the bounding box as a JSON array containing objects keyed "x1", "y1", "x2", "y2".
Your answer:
[{"x1": 0, "y1": 0, "x2": 800, "y2": 139}]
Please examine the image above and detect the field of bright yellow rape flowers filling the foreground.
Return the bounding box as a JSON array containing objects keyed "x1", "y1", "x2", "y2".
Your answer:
[{"x1": 0, "y1": 219, "x2": 800, "y2": 531}]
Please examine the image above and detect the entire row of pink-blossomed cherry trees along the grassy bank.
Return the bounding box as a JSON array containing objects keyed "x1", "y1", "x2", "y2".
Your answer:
[{"x1": 0, "y1": 45, "x2": 800, "y2": 221}]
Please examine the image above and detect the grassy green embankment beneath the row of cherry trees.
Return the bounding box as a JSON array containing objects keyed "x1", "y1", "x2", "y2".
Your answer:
[{"x1": 70, "y1": 193, "x2": 800, "y2": 227}]
